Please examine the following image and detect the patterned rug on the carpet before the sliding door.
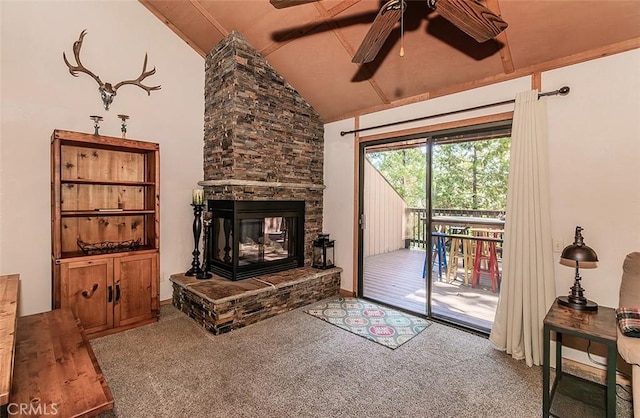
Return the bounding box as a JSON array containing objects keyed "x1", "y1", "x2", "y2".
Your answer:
[{"x1": 305, "y1": 297, "x2": 431, "y2": 349}]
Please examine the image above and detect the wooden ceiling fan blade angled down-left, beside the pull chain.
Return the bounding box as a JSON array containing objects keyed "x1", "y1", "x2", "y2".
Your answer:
[{"x1": 351, "y1": 0, "x2": 406, "y2": 64}]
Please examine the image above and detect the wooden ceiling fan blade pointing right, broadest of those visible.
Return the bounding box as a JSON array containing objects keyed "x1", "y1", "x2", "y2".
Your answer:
[{"x1": 427, "y1": 0, "x2": 508, "y2": 42}]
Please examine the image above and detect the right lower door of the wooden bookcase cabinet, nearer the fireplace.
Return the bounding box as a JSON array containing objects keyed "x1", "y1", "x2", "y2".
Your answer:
[{"x1": 114, "y1": 253, "x2": 159, "y2": 327}]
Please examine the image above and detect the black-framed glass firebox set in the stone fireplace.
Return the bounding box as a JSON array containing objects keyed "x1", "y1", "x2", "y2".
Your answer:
[{"x1": 205, "y1": 200, "x2": 304, "y2": 280}]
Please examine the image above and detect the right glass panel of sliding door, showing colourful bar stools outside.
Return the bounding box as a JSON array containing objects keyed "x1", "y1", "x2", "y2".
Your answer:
[{"x1": 431, "y1": 129, "x2": 510, "y2": 332}]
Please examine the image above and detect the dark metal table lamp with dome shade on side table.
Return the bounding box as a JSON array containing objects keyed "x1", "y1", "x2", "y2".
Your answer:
[{"x1": 558, "y1": 226, "x2": 598, "y2": 311}]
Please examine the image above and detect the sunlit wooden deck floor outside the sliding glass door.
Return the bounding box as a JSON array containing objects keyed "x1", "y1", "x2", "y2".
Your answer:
[{"x1": 363, "y1": 249, "x2": 498, "y2": 331}]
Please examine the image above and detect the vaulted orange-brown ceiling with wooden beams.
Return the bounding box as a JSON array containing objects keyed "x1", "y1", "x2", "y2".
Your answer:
[{"x1": 140, "y1": 0, "x2": 640, "y2": 122}]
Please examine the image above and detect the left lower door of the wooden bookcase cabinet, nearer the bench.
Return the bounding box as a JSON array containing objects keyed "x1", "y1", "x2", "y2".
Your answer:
[{"x1": 60, "y1": 259, "x2": 113, "y2": 334}]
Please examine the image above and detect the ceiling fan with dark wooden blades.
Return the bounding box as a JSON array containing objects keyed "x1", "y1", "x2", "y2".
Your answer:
[{"x1": 270, "y1": 0, "x2": 508, "y2": 64}]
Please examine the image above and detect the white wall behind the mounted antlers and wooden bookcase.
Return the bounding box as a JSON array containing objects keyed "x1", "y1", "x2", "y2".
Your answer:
[{"x1": 0, "y1": 0, "x2": 204, "y2": 315}]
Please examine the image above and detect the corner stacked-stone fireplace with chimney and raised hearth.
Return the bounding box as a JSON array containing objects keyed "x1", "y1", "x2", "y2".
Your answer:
[{"x1": 170, "y1": 32, "x2": 342, "y2": 334}]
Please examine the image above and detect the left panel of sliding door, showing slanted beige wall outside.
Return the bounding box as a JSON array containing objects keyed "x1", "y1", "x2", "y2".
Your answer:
[{"x1": 359, "y1": 139, "x2": 428, "y2": 314}]
